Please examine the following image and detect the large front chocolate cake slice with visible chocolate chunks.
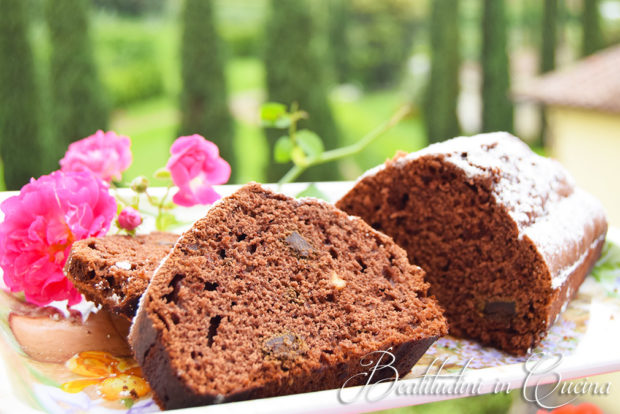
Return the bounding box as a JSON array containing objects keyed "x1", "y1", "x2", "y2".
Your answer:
[{"x1": 129, "y1": 184, "x2": 447, "y2": 409}]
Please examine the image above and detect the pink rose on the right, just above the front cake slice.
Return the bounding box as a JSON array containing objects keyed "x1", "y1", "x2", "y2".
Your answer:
[{"x1": 166, "y1": 135, "x2": 230, "y2": 207}]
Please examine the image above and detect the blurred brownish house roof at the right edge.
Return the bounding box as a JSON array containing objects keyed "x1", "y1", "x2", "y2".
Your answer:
[{"x1": 513, "y1": 45, "x2": 620, "y2": 113}]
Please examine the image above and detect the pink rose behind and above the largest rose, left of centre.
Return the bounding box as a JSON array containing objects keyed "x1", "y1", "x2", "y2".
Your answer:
[{"x1": 60, "y1": 130, "x2": 132, "y2": 182}]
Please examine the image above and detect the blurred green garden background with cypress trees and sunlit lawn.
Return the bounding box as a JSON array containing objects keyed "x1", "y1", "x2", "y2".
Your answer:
[{"x1": 0, "y1": 0, "x2": 620, "y2": 190}]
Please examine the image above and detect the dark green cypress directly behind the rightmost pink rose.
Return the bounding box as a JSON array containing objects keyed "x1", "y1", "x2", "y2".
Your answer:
[{"x1": 179, "y1": 0, "x2": 237, "y2": 182}]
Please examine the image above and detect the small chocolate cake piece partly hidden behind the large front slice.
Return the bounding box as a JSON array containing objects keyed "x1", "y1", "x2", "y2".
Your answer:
[{"x1": 65, "y1": 232, "x2": 179, "y2": 320}]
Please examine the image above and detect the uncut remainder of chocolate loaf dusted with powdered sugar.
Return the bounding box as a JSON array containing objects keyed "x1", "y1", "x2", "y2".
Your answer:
[{"x1": 336, "y1": 133, "x2": 607, "y2": 355}]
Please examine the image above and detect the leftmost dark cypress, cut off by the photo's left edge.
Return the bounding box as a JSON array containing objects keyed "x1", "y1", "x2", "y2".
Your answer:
[{"x1": 0, "y1": 0, "x2": 43, "y2": 190}]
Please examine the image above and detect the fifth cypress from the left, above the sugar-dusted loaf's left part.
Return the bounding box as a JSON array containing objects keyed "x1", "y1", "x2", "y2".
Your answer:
[{"x1": 424, "y1": 0, "x2": 461, "y2": 142}]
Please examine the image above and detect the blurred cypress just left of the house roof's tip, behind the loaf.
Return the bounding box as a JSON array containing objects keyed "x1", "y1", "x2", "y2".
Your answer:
[{"x1": 482, "y1": 0, "x2": 513, "y2": 131}]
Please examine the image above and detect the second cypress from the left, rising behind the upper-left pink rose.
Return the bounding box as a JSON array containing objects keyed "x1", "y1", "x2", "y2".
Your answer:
[{"x1": 46, "y1": 0, "x2": 108, "y2": 158}]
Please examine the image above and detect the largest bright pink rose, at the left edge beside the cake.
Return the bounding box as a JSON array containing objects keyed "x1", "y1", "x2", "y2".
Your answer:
[{"x1": 0, "y1": 171, "x2": 116, "y2": 306}]
